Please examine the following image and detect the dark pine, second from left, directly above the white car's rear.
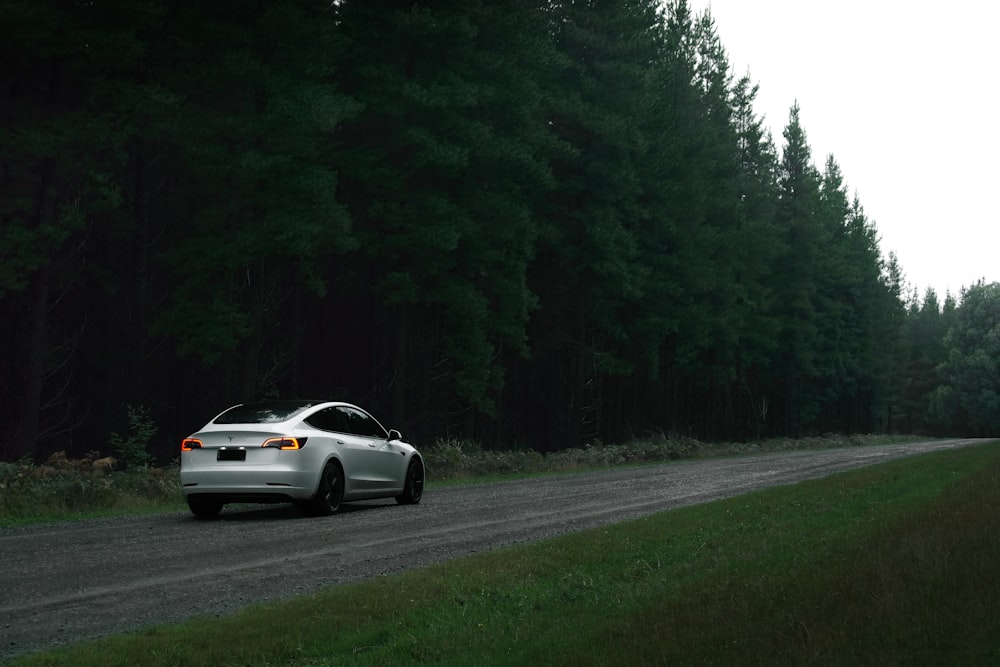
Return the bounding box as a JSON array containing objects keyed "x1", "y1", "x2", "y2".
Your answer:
[{"x1": 157, "y1": 0, "x2": 356, "y2": 400}]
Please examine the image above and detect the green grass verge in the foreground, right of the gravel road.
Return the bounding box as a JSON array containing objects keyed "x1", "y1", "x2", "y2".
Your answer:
[{"x1": 12, "y1": 443, "x2": 1000, "y2": 666}]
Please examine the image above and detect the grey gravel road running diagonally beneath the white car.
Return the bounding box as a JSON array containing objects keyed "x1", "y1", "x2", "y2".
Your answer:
[{"x1": 0, "y1": 440, "x2": 988, "y2": 662}]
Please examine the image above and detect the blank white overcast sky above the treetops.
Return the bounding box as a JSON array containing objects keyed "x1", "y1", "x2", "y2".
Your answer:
[{"x1": 688, "y1": 0, "x2": 1000, "y2": 301}]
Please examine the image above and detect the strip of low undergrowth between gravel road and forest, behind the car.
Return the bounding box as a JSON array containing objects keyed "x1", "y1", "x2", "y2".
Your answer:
[{"x1": 0, "y1": 435, "x2": 913, "y2": 526}]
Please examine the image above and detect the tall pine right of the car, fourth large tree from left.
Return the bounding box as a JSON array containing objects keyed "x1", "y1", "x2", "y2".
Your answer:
[{"x1": 529, "y1": 1, "x2": 662, "y2": 445}]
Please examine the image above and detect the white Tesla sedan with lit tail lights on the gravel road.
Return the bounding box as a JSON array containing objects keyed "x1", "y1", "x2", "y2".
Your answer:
[{"x1": 180, "y1": 401, "x2": 424, "y2": 518}]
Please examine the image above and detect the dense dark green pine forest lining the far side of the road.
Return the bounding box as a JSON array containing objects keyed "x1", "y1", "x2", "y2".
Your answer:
[{"x1": 0, "y1": 0, "x2": 1000, "y2": 461}]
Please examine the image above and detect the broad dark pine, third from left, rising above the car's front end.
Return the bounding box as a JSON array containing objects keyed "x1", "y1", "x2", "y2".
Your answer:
[{"x1": 339, "y1": 1, "x2": 560, "y2": 436}]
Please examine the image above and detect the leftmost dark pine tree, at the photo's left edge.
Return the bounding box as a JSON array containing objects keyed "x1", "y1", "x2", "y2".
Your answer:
[{"x1": 0, "y1": 1, "x2": 142, "y2": 458}]
